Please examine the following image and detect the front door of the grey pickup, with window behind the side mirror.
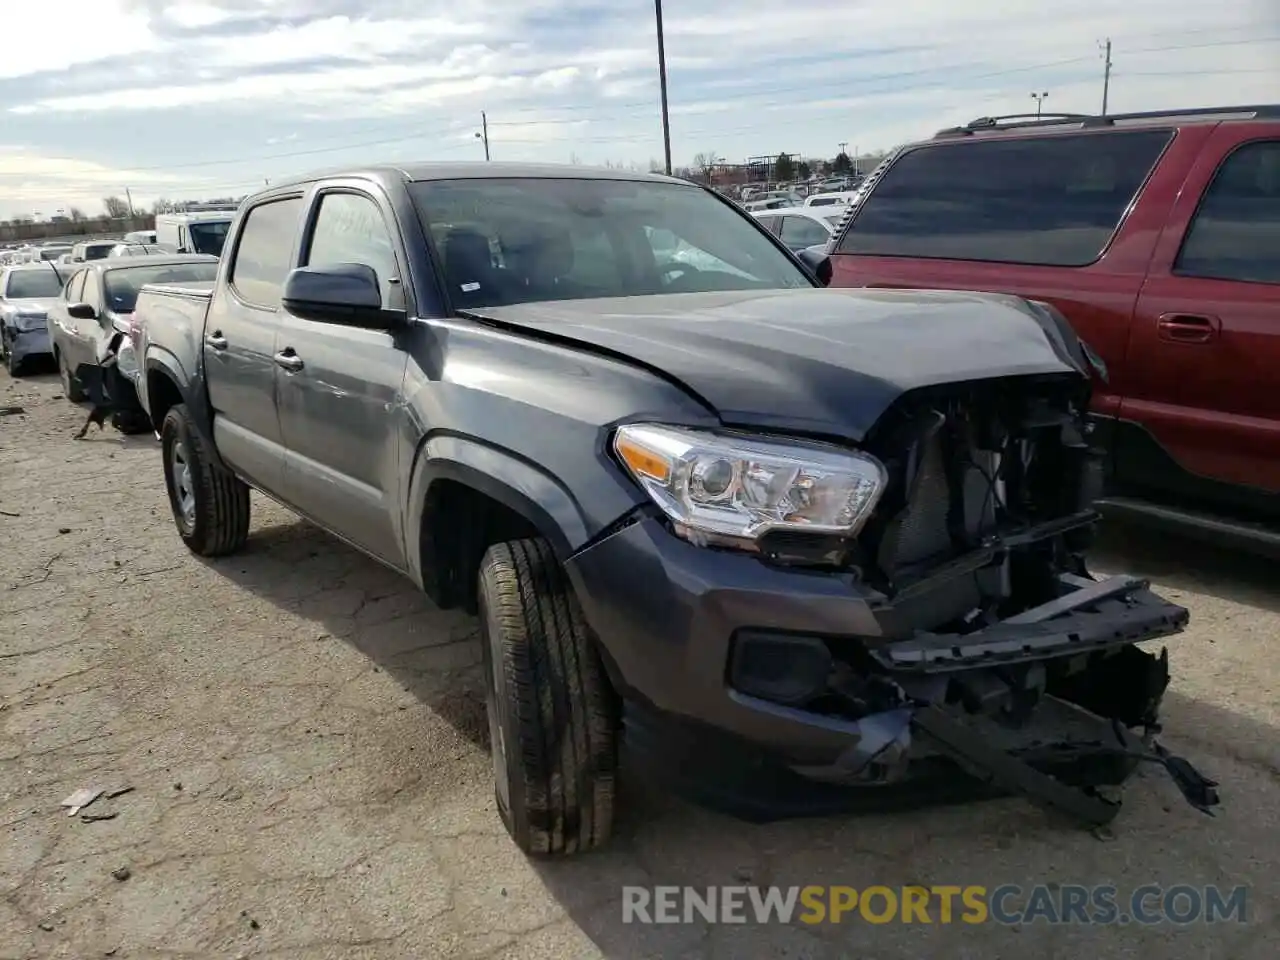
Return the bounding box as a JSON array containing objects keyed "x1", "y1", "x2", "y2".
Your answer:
[{"x1": 279, "y1": 188, "x2": 407, "y2": 568}]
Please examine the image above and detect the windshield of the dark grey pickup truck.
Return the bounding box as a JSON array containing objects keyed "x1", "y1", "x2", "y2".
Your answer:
[{"x1": 410, "y1": 178, "x2": 813, "y2": 308}]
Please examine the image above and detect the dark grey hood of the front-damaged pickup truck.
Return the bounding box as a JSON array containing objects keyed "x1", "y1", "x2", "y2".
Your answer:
[{"x1": 468, "y1": 288, "x2": 1089, "y2": 442}]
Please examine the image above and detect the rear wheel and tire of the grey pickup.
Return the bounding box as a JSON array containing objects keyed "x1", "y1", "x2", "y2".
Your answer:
[{"x1": 160, "y1": 403, "x2": 248, "y2": 557}]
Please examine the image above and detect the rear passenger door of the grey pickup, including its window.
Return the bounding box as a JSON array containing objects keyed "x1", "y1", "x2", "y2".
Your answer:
[{"x1": 204, "y1": 197, "x2": 303, "y2": 495}]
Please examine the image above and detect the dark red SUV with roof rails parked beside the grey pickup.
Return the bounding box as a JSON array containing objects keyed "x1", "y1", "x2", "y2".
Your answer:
[{"x1": 828, "y1": 106, "x2": 1280, "y2": 548}]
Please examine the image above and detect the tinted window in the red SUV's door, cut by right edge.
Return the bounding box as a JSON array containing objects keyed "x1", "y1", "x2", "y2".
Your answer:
[{"x1": 1174, "y1": 141, "x2": 1280, "y2": 283}]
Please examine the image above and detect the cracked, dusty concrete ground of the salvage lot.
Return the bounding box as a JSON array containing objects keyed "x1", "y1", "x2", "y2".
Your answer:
[{"x1": 0, "y1": 371, "x2": 1280, "y2": 960}]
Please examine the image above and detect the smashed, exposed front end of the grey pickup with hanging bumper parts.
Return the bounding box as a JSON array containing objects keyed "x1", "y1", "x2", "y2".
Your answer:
[{"x1": 728, "y1": 376, "x2": 1219, "y2": 824}]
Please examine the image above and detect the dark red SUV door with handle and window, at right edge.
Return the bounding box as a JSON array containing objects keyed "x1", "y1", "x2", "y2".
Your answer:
[{"x1": 1119, "y1": 131, "x2": 1280, "y2": 511}]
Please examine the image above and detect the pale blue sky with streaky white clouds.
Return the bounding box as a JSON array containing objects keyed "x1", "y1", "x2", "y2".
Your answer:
[{"x1": 0, "y1": 0, "x2": 1280, "y2": 218}]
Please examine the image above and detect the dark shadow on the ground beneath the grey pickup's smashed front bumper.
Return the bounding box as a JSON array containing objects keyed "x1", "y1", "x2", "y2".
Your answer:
[{"x1": 524, "y1": 694, "x2": 1280, "y2": 960}]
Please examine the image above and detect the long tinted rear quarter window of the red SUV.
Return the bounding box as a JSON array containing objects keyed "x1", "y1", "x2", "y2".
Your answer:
[{"x1": 837, "y1": 131, "x2": 1172, "y2": 266}]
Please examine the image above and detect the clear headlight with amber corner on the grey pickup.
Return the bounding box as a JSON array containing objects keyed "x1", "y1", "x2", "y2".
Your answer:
[{"x1": 613, "y1": 424, "x2": 887, "y2": 545}]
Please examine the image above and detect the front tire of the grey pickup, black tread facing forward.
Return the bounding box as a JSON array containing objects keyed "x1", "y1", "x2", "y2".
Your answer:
[{"x1": 479, "y1": 540, "x2": 618, "y2": 856}]
